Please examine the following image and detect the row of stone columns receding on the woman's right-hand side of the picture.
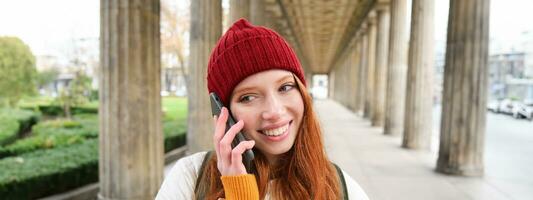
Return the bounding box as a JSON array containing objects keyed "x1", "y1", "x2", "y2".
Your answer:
[{"x1": 330, "y1": 0, "x2": 489, "y2": 175}]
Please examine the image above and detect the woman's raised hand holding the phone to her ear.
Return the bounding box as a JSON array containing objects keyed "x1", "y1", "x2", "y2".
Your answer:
[{"x1": 213, "y1": 107, "x2": 255, "y2": 176}]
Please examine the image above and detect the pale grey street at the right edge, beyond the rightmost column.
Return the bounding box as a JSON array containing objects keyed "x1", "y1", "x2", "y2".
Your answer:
[{"x1": 432, "y1": 105, "x2": 533, "y2": 199}]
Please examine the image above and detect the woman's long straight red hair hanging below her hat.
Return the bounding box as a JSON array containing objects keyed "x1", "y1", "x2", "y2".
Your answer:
[{"x1": 196, "y1": 76, "x2": 342, "y2": 200}]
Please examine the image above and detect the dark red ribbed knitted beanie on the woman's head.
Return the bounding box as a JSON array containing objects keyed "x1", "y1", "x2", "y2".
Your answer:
[{"x1": 207, "y1": 19, "x2": 306, "y2": 106}]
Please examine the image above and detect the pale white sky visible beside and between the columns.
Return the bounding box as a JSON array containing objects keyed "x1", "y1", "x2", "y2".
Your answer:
[{"x1": 0, "y1": 0, "x2": 533, "y2": 56}]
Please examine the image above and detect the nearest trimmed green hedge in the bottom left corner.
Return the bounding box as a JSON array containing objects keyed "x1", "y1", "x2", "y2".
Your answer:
[{"x1": 0, "y1": 139, "x2": 98, "y2": 199}]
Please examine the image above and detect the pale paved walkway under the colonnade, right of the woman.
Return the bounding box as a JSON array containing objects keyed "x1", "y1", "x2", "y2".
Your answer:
[{"x1": 315, "y1": 100, "x2": 533, "y2": 200}]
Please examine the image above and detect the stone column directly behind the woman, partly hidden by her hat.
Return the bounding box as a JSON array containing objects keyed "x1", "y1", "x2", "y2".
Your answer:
[{"x1": 187, "y1": 0, "x2": 222, "y2": 153}]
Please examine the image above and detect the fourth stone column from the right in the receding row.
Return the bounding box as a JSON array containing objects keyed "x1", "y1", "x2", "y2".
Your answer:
[{"x1": 372, "y1": 3, "x2": 390, "y2": 126}]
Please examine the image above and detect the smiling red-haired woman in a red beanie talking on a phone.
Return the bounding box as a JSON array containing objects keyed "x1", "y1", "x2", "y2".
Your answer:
[{"x1": 156, "y1": 19, "x2": 368, "y2": 200}]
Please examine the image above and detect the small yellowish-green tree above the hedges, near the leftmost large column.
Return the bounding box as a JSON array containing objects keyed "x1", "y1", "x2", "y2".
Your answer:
[{"x1": 56, "y1": 71, "x2": 92, "y2": 118}]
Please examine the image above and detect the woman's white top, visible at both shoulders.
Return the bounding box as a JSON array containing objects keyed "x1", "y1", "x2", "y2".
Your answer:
[{"x1": 155, "y1": 152, "x2": 368, "y2": 200}]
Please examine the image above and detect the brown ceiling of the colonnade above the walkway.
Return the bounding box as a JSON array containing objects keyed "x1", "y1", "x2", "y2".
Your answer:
[{"x1": 265, "y1": 0, "x2": 376, "y2": 74}]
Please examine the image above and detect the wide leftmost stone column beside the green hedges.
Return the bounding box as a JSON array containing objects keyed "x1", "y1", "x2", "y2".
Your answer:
[{"x1": 98, "y1": 0, "x2": 164, "y2": 199}]
